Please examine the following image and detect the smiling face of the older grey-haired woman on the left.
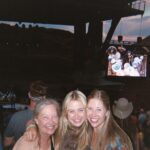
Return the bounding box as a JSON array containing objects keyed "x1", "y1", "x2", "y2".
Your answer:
[{"x1": 35, "y1": 104, "x2": 59, "y2": 136}]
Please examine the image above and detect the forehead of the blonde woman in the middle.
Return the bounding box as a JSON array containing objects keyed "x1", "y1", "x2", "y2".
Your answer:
[{"x1": 67, "y1": 100, "x2": 84, "y2": 109}]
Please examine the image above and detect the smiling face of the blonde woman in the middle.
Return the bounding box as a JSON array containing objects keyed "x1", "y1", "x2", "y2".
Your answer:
[{"x1": 67, "y1": 100, "x2": 86, "y2": 127}]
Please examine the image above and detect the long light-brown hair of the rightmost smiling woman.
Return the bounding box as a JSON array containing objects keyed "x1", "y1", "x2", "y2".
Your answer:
[{"x1": 88, "y1": 89, "x2": 133, "y2": 150}]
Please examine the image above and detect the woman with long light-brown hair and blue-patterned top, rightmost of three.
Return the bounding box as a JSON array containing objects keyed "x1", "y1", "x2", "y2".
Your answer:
[{"x1": 87, "y1": 90, "x2": 133, "y2": 150}]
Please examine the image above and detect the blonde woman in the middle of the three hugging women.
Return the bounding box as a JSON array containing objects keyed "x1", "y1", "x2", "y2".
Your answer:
[{"x1": 55, "y1": 90, "x2": 88, "y2": 150}]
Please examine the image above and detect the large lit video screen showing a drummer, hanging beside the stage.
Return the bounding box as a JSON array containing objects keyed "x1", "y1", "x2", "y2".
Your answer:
[{"x1": 107, "y1": 46, "x2": 148, "y2": 77}]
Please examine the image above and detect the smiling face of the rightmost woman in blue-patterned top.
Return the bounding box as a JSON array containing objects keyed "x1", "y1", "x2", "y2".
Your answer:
[{"x1": 87, "y1": 98, "x2": 107, "y2": 129}]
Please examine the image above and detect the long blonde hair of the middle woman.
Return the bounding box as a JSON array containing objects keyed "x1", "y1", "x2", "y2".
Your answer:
[{"x1": 55, "y1": 90, "x2": 88, "y2": 150}]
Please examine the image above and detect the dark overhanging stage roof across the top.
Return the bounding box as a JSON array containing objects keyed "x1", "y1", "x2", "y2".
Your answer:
[{"x1": 0, "y1": 0, "x2": 144, "y2": 25}]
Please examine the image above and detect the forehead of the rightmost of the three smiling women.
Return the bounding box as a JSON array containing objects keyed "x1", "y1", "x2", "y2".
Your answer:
[{"x1": 87, "y1": 98, "x2": 104, "y2": 107}]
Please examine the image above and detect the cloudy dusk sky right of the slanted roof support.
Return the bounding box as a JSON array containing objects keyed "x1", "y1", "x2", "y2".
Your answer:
[{"x1": 110, "y1": 0, "x2": 150, "y2": 41}]
